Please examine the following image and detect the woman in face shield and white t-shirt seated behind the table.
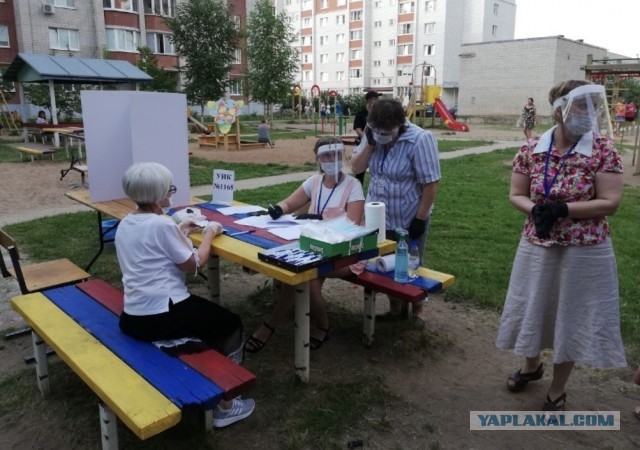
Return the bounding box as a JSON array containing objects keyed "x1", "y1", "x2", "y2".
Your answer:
[{"x1": 244, "y1": 136, "x2": 364, "y2": 353}]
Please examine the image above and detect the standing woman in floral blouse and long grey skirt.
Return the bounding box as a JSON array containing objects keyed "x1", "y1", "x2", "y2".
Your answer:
[{"x1": 496, "y1": 80, "x2": 626, "y2": 411}]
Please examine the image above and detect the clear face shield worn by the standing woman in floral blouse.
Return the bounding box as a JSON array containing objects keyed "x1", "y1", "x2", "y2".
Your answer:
[{"x1": 553, "y1": 84, "x2": 613, "y2": 136}]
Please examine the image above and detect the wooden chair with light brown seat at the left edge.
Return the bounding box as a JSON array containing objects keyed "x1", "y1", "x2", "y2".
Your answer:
[{"x1": 0, "y1": 230, "x2": 91, "y2": 294}]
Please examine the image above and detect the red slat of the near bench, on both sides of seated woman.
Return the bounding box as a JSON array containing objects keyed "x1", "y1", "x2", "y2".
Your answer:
[{"x1": 76, "y1": 279, "x2": 257, "y2": 400}]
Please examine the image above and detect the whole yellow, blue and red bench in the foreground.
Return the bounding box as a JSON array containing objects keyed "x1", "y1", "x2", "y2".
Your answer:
[{"x1": 11, "y1": 280, "x2": 256, "y2": 449}]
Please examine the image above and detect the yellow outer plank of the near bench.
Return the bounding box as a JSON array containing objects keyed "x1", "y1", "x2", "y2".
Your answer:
[{"x1": 11, "y1": 293, "x2": 181, "y2": 439}]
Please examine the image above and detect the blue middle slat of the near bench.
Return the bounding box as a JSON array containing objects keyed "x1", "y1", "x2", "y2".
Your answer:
[{"x1": 45, "y1": 286, "x2": 223, "y2": 409}]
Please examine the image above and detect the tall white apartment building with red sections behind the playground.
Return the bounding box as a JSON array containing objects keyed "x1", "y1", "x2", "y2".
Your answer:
[{"x1": 275, "y1": 0, "x2": 516, "y2": 103}]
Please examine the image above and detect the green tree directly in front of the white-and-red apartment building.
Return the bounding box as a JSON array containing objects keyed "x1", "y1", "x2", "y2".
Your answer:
[{"x1": 247, "y1": 0, "x2": 299, "y2": 118}]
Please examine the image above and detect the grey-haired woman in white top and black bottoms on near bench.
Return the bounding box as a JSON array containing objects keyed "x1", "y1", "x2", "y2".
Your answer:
[{"x1": 115, "y1": 162, "x2": 255, "y2": 427}]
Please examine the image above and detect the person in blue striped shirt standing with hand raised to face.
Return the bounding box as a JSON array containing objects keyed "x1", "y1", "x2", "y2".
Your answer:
[{"x1": 351, "y1": 99, "x2": 440, "y2": 328}]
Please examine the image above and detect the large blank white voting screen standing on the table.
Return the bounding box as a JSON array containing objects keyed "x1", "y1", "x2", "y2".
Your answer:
[{"x1": 81, "y1": 91, "x2": 191, "y2": 206}]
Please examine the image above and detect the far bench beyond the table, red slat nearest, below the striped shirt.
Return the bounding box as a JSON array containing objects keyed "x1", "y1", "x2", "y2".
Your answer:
[{"x1": 345, "y1": 267, "x2": 455, "y2": 347}]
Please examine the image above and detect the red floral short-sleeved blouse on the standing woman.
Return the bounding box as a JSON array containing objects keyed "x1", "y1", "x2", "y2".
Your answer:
[{"x1": 513, "y1": 128, "x2": 622, "y2": 247}]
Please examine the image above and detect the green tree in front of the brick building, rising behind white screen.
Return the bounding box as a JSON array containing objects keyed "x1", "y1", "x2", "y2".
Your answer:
[{"x1": 166, "y1": 0, "x2": 240, "y2": 106}]
